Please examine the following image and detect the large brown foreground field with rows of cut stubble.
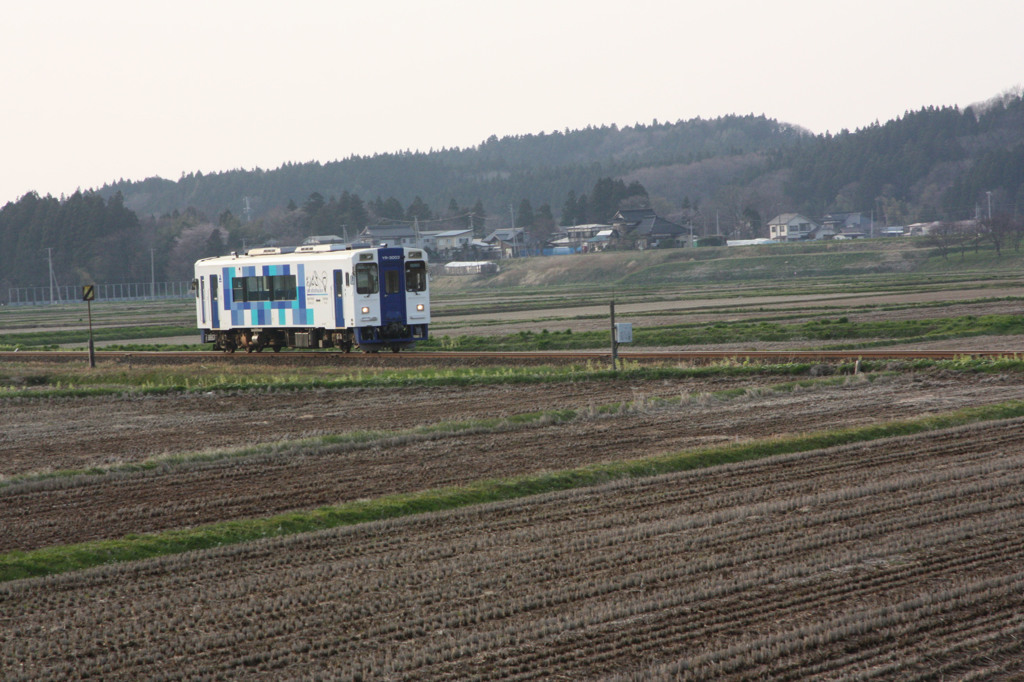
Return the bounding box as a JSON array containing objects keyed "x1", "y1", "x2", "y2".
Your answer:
[{"x1": 0, "y1": 411, "x2": 1024, "y2": 680}]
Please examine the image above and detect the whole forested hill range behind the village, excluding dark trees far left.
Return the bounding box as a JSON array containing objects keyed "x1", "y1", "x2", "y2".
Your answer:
[{"x1": 94, "y1": 93, "x2": 1024, "y2": 228}]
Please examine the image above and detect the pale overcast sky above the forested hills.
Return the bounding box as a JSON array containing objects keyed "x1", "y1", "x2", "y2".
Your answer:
[{"x1": 0, "y1": 0, "x2": 1024, "y2": 205}]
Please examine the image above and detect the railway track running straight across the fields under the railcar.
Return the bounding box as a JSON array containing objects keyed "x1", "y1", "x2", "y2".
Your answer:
[{"x1": 0, "y1": 349, "x2": 1024, "y2": 367}]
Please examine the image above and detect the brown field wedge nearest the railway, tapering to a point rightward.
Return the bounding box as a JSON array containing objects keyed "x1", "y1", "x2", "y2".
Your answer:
[{"x1": 0, "y1": 377, "x2": 753, "y2": 476}]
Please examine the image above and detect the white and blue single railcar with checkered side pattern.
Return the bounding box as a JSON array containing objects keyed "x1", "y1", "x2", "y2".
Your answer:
[{"x1": 193, "y1": 244, "x2": 430, "y2": 352}]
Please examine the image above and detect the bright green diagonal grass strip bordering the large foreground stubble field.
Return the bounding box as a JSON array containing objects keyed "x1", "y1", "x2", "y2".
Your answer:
[{"x1": 0, "y1": 400, "x2": 1024, "y2": 582}]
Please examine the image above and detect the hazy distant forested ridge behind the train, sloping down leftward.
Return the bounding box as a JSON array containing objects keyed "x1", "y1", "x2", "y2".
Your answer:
[{"x1": 100, "y1": 116, "x2": 801, "y2": 222}]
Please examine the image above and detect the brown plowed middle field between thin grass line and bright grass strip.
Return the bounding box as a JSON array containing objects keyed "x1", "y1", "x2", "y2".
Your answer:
[{"x1": 8, "y1": 372, "x2": 1024, "y2": 551}]
